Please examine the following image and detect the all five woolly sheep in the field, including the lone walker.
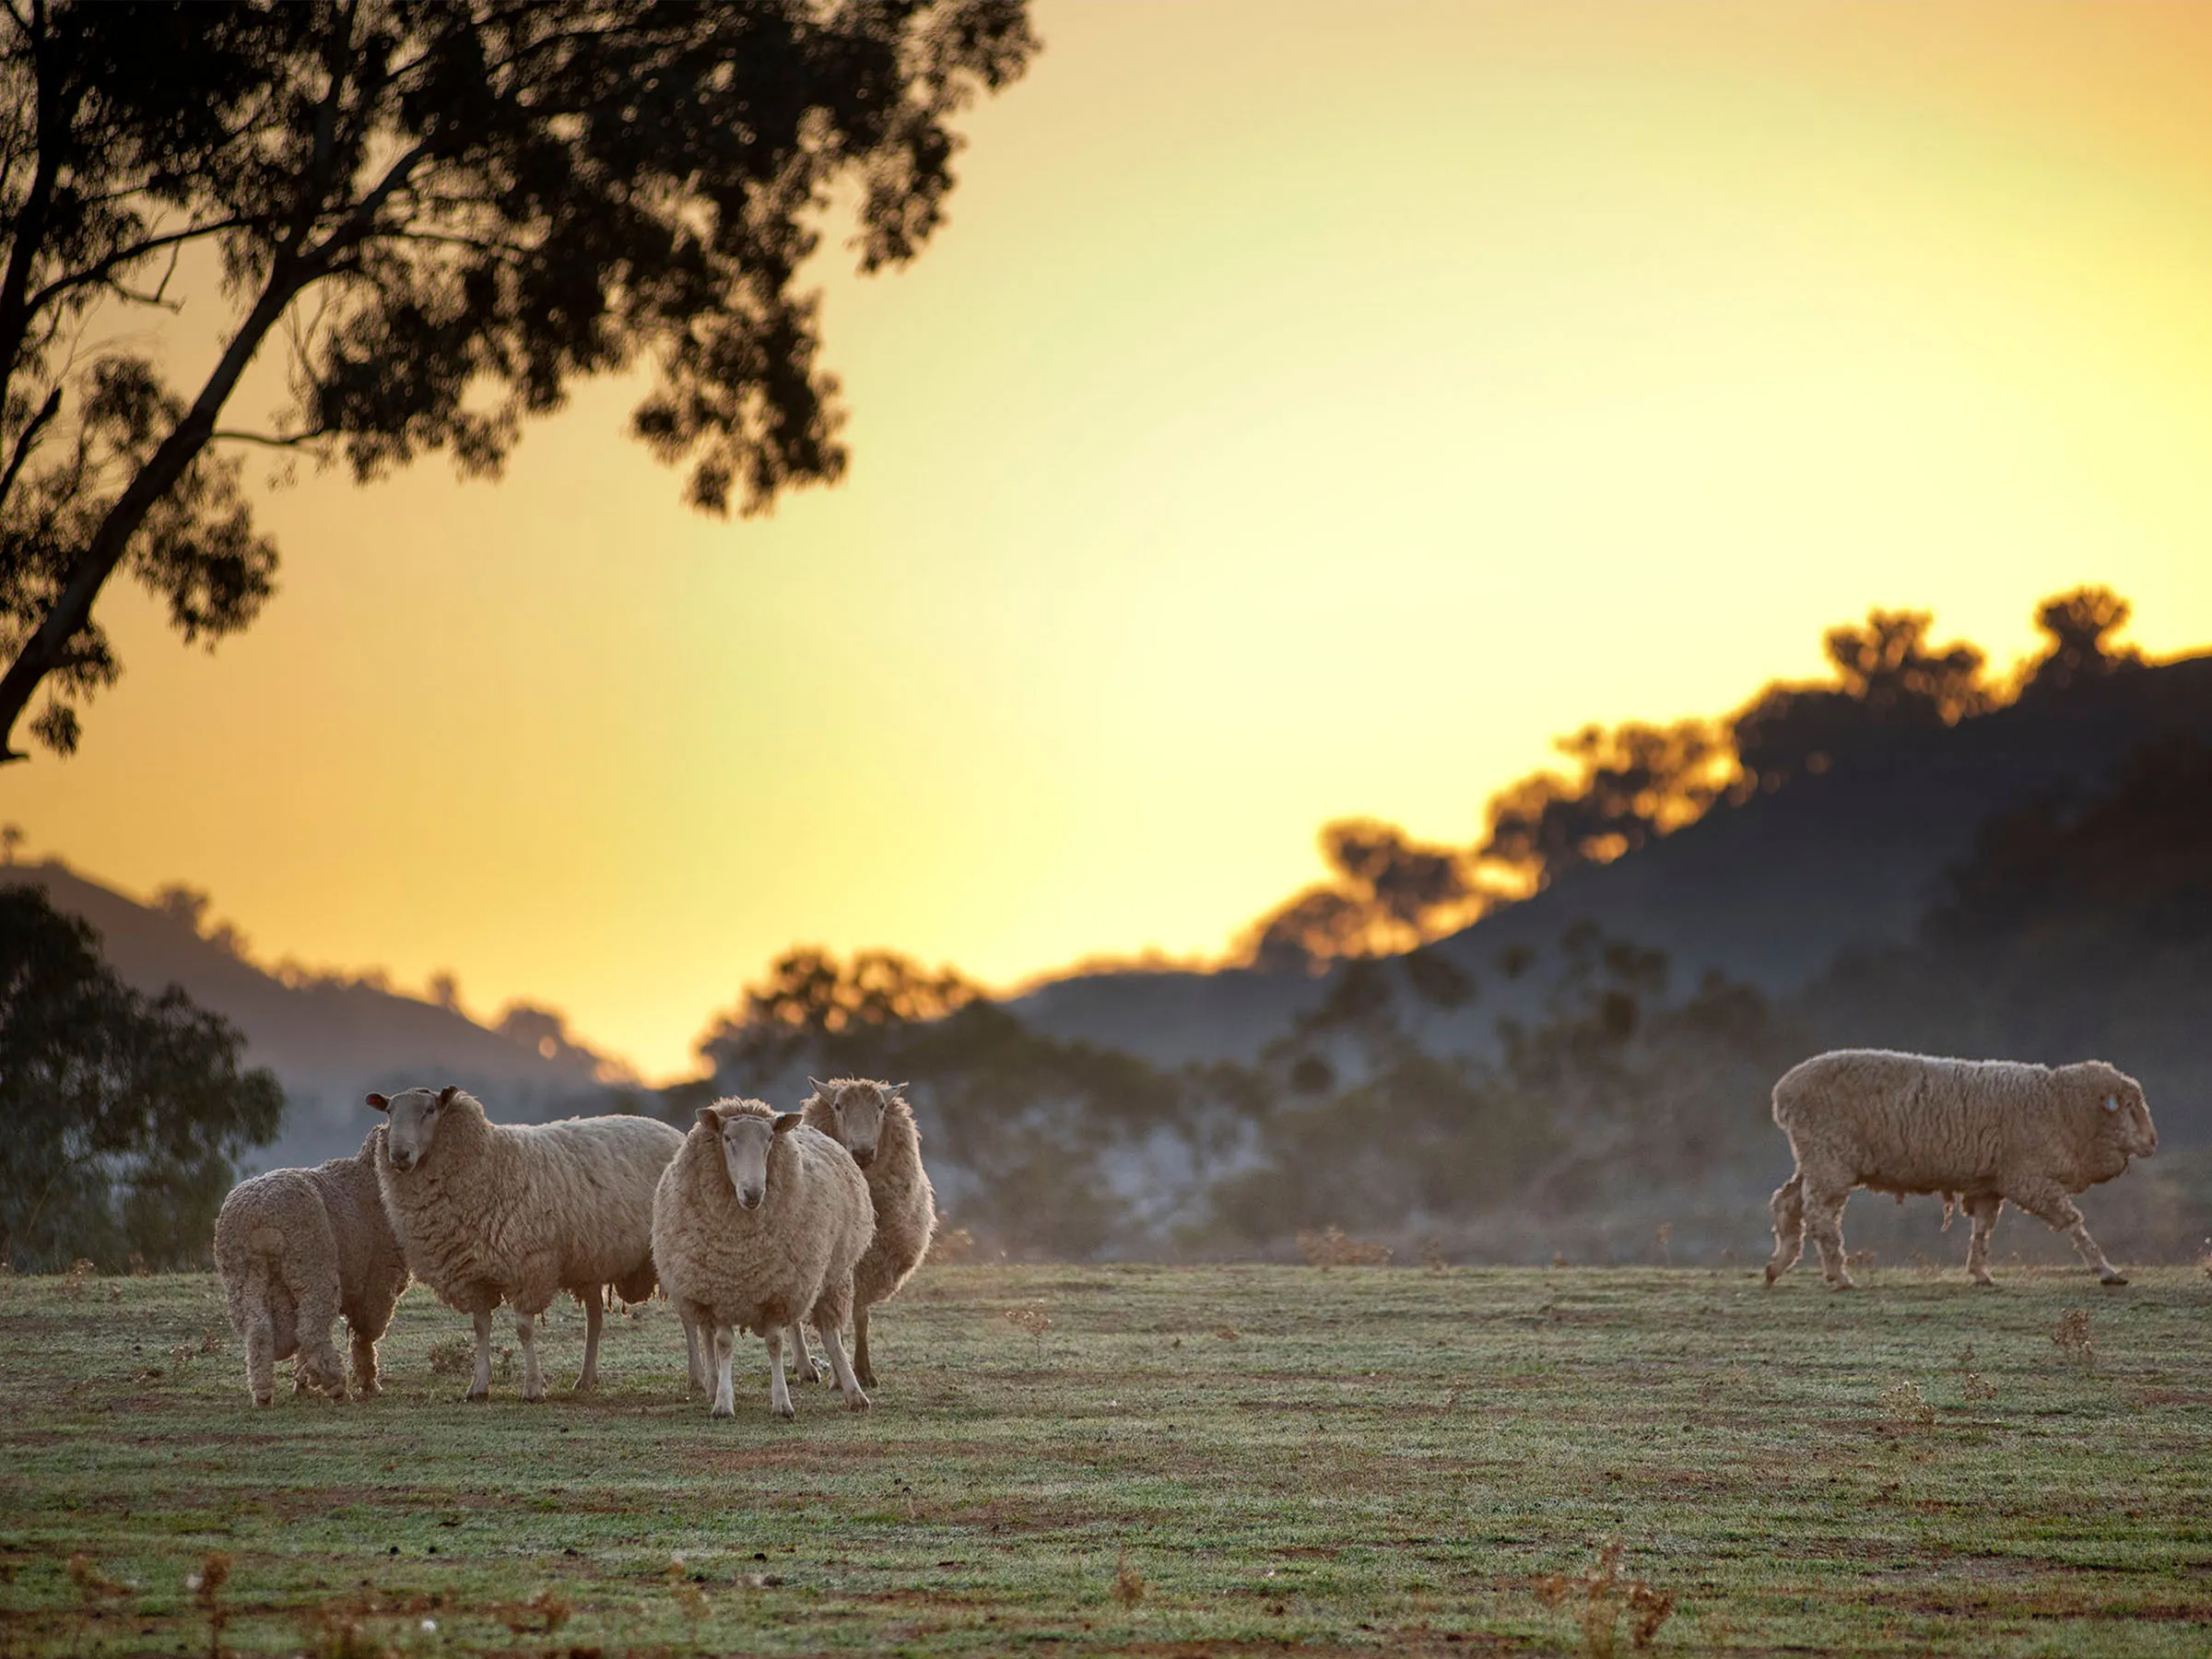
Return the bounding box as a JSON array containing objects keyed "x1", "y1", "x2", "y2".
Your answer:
[{"x1": 215, "y1": 1049, "x2": 2159, "y2": 1418}]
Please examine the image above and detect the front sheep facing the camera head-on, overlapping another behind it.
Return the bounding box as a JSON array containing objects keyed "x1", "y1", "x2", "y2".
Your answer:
[{"x1": 653, "y1": 1100, "x2": 876, "y2": 1418}]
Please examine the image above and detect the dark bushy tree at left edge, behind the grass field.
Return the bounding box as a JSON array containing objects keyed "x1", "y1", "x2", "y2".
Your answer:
[{"x1": 0, "y1": 887, "x2": 283, "y2": 1270}]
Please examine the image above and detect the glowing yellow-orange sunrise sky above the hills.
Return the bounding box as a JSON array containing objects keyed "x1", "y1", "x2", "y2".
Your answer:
[{"x1": 0, "y1": 0, "x2": 2212, "y2": 1079}]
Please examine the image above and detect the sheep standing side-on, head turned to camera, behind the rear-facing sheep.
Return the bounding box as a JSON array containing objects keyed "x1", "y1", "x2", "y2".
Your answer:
[{"x1": 370, "y1": 1088, "x2": 684, "y2": 1400}]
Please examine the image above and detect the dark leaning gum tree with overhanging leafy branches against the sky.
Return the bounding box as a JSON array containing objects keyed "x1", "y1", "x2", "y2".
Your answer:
[{"x1": 0, "y1": 0, "x2": 1038, "y2": 761}]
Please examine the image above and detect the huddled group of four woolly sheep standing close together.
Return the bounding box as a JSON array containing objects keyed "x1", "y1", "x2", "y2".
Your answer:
[{"x1": 215, "y1": 1077, "x2": 935, "y2": 1418}]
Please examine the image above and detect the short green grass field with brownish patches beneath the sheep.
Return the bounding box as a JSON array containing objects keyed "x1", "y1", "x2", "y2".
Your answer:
[{"x1": 0, "y1": 1265, "x2": 2212, "y2": 1659}]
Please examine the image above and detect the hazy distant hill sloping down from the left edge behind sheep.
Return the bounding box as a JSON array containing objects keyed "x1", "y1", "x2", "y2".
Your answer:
[{"x1": 0, "y1": 863, "x2": 623, "y2": 1168}]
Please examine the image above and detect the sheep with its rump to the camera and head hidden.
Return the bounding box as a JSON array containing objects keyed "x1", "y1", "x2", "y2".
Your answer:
[{"x1": 215, "y1": 1124, "x2": 407, "y2": 1405}]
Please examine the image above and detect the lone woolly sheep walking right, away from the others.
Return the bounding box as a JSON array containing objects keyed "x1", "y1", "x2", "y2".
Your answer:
[{"x1": 1768, "y1": 1049, "x2": 2159, "y2": 1289}]
